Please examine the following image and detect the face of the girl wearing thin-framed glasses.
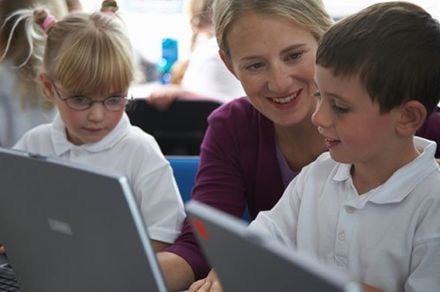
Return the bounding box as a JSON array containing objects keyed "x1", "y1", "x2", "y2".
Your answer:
[{"x1": 43, "y1": 74, "x2": 127, "y2": 145}]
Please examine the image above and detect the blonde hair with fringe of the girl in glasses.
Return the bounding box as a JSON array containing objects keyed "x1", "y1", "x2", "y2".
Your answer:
[{"x1": 1, "y1": 2, "x2": 135, "y2": 94}]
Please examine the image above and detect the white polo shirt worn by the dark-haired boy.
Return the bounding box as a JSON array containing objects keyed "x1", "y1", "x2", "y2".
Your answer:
[{"x1": 250, "y1": 138, "x2": 440, "y2": 292}]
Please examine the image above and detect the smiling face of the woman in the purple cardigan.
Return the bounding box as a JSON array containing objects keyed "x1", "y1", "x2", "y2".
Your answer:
[{"x1": 221, "y1": 13, "x2": 318, "y2": 126}]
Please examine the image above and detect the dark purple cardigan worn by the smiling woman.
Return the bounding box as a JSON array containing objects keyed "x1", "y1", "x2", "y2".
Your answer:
[{"x1": 167, "y1": 97, "x2": 440, "y2": 280}]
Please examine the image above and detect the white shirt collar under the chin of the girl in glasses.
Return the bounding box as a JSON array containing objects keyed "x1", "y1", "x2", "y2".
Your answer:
[{"x1": 51, "y1": 113, "x2": 130, "y2": 156}]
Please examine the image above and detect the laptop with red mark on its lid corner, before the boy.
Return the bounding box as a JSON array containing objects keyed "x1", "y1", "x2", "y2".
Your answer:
[{"x1": 185, "y1": 201, "x2": 362, "y2": 292}]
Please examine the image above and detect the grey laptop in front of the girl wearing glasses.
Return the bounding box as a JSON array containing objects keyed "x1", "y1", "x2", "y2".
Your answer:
[{"x1": 0, "y1": 148, "x2": 167, "y2": 292}]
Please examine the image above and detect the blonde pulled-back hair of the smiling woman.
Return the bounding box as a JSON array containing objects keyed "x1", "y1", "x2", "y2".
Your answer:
[{"x1": 213, "y1": 0, "x2": 333, "y2": 55}]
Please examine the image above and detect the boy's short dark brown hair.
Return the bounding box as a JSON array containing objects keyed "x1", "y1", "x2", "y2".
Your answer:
[{"x1": 316, "y1": 2, "x2": 440, "y2": 114}]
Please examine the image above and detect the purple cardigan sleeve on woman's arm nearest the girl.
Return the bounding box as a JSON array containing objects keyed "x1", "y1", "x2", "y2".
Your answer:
[{"x1": 163, "y1": 99, "x2": 246, "y2": 280}]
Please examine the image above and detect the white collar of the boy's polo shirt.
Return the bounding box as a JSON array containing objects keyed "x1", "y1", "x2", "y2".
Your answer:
[{"x1": 333, "y1": 137, "x2": 438, "y2": 204}]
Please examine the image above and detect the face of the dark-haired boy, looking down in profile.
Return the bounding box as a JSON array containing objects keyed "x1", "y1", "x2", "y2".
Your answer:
[{"x1": 312, "y1": 66, "x2": 398, "y2": 165}]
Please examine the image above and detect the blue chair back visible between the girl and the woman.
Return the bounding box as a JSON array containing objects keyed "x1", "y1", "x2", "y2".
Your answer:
[{"x1": 166, "y1": 155, "x2": 199, "y2": 203}]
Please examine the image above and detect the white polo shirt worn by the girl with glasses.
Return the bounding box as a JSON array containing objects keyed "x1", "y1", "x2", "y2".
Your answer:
[{"x1": 14, "y1": 113, "x2": 185, "y2": 243}]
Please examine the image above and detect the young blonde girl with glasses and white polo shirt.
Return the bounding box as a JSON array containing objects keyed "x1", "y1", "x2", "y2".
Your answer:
[{"x1": 9, "y1": 1, "x2": 184, "y2": 250}]
